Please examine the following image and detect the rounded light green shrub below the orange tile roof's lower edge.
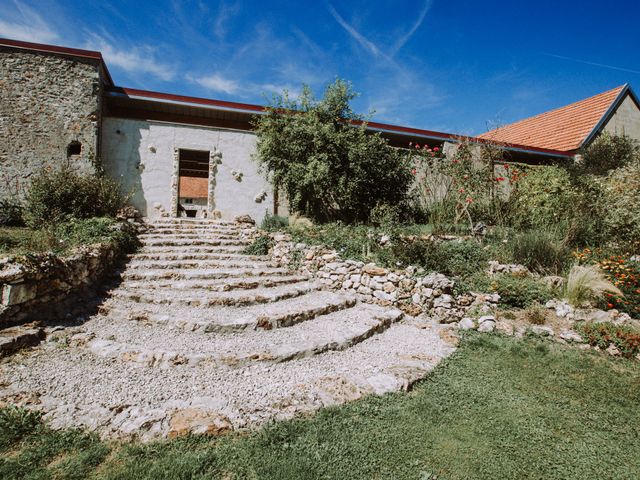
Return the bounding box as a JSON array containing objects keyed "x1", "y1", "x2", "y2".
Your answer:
[{"x1": 513, "y1": 166, "x2": 575, "y2": 228}]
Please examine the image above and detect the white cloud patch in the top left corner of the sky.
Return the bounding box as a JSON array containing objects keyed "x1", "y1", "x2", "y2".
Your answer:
[{"x1": 0, "y1": 0, "x2": 60, "y2": 43}]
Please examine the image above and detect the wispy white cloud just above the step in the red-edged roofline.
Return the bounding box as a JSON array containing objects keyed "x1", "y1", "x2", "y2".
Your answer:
[{"x1": 86, "y1": 33, "x2": 175, "y2": 82}]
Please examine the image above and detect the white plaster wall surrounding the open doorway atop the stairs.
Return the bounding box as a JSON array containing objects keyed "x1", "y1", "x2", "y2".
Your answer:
[{"x1": 102, "y1": 118, "x2": 273, "y2": 222}]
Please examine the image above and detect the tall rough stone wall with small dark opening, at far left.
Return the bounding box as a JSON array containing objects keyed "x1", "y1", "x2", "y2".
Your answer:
[{"x1": 0, "y1": 47, "x2": 102, "y2": 198}]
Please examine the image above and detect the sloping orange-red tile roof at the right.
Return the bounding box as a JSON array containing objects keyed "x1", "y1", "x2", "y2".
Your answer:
[{"x1": 478, "y1": 85, "x2": 625, "y2": 152}]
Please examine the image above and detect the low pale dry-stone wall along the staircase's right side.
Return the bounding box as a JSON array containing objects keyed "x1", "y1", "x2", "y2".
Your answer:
[{"x1": 271, "y1": 234, "x2": 500, "y2": 323}]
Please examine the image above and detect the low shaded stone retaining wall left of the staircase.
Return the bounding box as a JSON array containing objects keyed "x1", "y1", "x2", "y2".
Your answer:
[{"x1": 0, "y1": 244, "x2": 126, "y2": 327}]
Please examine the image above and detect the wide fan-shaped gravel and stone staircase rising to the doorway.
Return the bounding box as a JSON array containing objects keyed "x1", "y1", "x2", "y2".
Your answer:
[{"x1": 0, "y1": 219, "x2": 453, "y2": 439}]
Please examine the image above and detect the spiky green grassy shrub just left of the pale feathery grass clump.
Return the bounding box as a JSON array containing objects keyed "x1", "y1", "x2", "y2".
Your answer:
[{"x1": 508, "y1": 230, "x2": 571, "y2": 275}]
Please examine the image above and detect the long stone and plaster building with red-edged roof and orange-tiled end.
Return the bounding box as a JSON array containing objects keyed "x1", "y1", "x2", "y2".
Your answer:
[{"x1": 0, "y1": 39, "x2": 640, "y2": 221}]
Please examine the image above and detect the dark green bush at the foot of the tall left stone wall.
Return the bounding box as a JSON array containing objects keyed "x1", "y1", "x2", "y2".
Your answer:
[{"x1": 25, "y1": 168, "x2": 126, "y2": 228}]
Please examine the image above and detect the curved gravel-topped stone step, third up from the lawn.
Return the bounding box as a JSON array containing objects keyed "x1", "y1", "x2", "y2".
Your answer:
[{"x1": 103, "y1": 290, "x2": 356, "y2": 333}]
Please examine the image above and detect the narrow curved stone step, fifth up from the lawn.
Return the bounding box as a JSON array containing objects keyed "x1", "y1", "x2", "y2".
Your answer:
[{"x1": 121, "y1": 275, "x2": 309, "y2": 292}]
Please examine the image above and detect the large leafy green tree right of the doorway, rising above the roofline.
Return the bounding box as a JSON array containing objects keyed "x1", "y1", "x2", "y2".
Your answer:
[{"x1": 254, "y1": 79, "x2": 412, "y2": 223}]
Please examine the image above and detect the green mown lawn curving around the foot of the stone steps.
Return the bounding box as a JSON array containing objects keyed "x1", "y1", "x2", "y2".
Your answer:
[{"x1": 0, "y1": 334, "x2": 640, "y2": 480}]
